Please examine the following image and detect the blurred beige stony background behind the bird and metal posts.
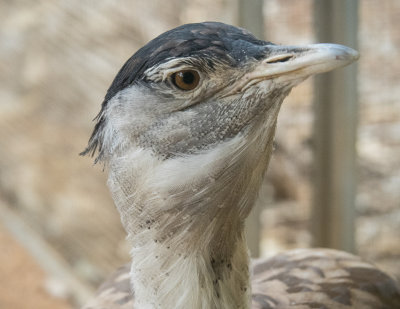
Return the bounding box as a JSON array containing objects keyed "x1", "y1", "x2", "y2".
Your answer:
[{"x1": 0, "y1": 0, "x2": 400, "y2": 309}]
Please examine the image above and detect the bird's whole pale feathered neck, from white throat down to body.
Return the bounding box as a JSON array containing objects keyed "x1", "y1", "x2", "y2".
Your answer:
[{"x1": 108, "y1": 104, "x2": 276, "y2": 309}]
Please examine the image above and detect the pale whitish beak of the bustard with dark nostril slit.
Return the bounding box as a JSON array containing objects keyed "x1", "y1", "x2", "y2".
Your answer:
[{"x1": 234, "y1": 44, "x2": 359, "y2": 92}]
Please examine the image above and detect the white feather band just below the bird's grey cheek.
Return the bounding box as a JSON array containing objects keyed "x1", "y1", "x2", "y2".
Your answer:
[{"x1": 104, "y1": 132, "x2": 245, "y2": 224}]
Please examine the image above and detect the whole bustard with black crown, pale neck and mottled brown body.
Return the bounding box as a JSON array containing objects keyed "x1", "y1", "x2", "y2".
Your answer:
[{"x1": 84, "y1": 22, "x2": 400, "y2": 309}]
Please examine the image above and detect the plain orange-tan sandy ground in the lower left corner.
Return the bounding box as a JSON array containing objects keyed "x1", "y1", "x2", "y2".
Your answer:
[{"x1": 0, "y1": 226, "x2": 72, "y2": 309}]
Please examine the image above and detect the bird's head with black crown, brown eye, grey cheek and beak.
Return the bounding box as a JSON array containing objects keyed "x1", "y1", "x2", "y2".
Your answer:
[{"x1": 84, "y1": 22, "x2": 358, "y2": 165}]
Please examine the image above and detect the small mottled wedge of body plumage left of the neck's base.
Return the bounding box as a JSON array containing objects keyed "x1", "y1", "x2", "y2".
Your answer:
[{"x1": 83, "y1": 264, "x2": 134, "y2": 309}]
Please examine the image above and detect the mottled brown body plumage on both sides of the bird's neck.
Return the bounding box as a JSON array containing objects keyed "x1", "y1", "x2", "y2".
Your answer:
[{"x1": 84, "y1": 249, "x2": 400, "y2": 309}]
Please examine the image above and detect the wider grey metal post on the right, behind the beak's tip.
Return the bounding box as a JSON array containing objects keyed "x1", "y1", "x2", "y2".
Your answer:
[{"x1": 312, "y1": 0, "x2": 358, "y2": 252}]
